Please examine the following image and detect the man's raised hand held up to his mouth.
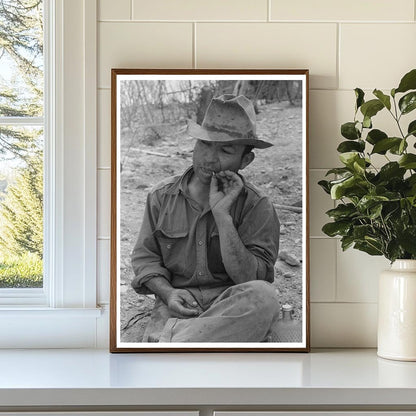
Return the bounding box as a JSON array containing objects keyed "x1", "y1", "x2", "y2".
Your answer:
[{"x1": 209, "y1": 170, "x2": 244, "y2": 217}]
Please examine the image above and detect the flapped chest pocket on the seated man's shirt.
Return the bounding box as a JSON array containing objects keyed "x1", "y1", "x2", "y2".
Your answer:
[{"x1": 154, "y1": 227, "x2": 188, "y2": 275}]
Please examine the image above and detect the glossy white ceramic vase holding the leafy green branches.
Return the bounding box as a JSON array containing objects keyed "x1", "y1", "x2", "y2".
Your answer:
[{"x1": 377, "y1": 260, "x2": 416, "y2": 361}]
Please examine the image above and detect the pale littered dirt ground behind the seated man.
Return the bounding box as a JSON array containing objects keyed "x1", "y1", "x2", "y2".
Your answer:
[{"x1": 120, "y1": 102, "x2": 304, "y2": 342}]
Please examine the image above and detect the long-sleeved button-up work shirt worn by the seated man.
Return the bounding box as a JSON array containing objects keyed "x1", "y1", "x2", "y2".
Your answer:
[{"x1": 132, "y1": 167, "x2": 279, "y2": 309}]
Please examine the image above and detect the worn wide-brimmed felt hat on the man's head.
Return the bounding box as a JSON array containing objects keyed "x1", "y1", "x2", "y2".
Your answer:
[{"x1": 188, "y1": 94, "x2": 273, "y2": 149}]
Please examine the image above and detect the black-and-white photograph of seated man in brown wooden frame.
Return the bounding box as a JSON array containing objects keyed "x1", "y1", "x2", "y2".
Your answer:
[{"x1": 110, "y1": 69, "x2": 309, "y2": 352}]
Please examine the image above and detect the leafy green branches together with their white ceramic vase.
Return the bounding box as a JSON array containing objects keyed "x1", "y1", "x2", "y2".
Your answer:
[{"x1": 319, "y1": 69, "x2": 416, "y2": 361}]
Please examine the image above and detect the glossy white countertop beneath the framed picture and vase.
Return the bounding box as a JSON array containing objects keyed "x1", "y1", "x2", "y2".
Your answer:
[{"x1": 0, "y1": 349, "x2": 416, "y2": 407}]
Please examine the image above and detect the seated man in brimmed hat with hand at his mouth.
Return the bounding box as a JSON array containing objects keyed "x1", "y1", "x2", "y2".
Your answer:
[{"x1": 132, "y1": 95, "x2": 280, "y2": 342}]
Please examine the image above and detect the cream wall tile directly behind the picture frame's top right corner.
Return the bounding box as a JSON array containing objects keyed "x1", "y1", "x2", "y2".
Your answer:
[{"x1": 196, "y1": 23, "x2": 337, "y2": 88}]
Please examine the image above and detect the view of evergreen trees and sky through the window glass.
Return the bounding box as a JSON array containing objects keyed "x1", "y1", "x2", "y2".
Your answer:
[{"x1": 0, "y1": 0, "x2": 44, "y2": 289}]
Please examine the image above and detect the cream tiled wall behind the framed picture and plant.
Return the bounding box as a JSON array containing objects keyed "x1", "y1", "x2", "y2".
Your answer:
[{"x1": 98, "y1": 0, "x2": 416, "y2": 347}]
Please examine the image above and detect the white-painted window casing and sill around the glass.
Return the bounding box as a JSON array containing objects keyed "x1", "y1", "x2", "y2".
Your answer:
[{"x1": 0, "y1": 0, "x2": 101, "y2": 348}]
